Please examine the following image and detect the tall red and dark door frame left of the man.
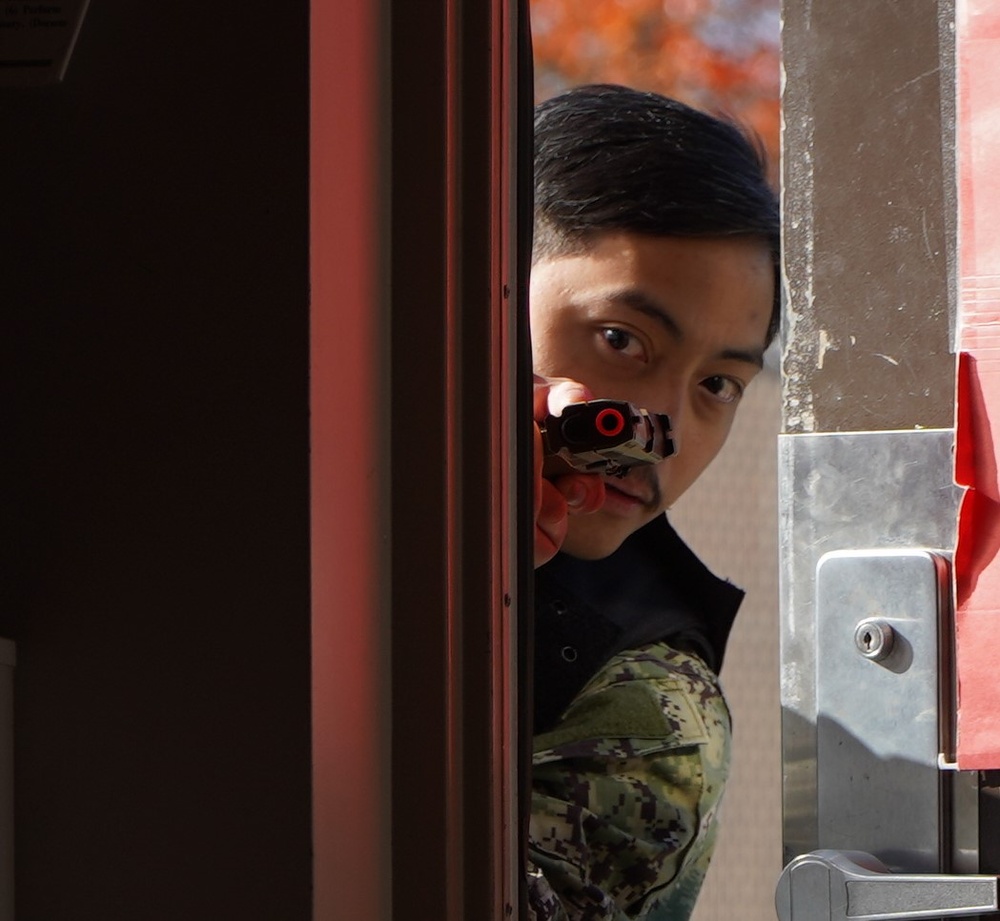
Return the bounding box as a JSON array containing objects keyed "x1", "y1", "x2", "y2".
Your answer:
[{"x1": 310, "y1": 0, "x2": 519, "y2": 921}]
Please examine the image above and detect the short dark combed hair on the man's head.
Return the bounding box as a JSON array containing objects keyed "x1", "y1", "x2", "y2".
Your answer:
[{"x1": 532, "y1": 85, "x2": 781, "y2": 342}]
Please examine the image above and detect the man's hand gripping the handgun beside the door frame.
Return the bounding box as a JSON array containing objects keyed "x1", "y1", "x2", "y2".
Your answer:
[{"x1": 534, "y1": 374, "x2": 604, "y2": 567}]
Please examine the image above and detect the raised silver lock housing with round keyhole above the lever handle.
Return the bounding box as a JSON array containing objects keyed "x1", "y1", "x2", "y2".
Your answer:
[{"x1": 816, "y1": 549, "x2": 950, "y2": 872}]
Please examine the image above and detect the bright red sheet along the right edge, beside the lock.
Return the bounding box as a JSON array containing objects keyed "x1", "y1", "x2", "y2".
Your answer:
[{"x1": 955, "y1": 0, "x2": 1000, "y2": 770}]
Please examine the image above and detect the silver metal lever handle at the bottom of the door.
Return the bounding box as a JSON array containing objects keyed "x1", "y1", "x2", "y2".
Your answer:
[{"x1": 774, "y1": 850, "x2": 997, "y2": 921}]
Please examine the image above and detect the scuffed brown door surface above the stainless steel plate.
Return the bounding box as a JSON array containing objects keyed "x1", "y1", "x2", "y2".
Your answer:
[{"x1": 782, "y1": 0, "x2": 955, "y2": 432}]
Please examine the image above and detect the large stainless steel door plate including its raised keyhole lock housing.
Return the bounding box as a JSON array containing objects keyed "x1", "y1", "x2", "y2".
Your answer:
[{"x1": 779, "y1": 429, "x2": 960, "y2": 873}]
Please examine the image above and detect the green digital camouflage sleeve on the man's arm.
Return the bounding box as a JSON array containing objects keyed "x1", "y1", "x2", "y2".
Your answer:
[{"x1": 528, "y1": 644, "x2": 730, "y2": 921}]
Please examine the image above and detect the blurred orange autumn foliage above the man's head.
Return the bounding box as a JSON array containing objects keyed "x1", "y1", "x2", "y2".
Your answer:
[{"x1": 530, "y1": 0, "x2": 780, "y2": 166}]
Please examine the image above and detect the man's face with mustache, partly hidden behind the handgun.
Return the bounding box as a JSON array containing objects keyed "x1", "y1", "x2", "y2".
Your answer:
[{"x1": 530, "y1": 232, "x2": 774, "y2": 559}]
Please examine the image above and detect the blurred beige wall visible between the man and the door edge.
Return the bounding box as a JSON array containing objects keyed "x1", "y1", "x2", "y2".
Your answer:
[{"x1": 670, "y1": 371, "x2": 781, "y2": 921}]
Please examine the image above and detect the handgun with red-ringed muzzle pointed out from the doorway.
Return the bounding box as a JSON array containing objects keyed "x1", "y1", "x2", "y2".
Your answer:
[{"x1": 539, "y1": 400, "x2": 675, "y2": 477}]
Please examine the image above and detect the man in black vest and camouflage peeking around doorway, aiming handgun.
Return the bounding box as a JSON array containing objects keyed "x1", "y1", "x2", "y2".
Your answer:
[{"x1": 528, "y1": 86, "x2": 779, "y2": 921}]
